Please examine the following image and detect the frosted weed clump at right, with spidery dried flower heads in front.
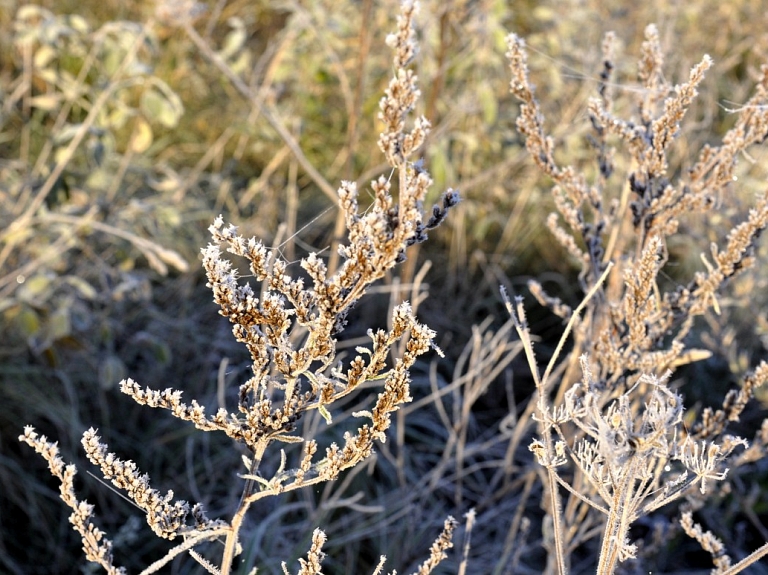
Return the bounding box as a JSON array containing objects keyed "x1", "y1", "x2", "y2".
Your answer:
[{"x1": 505, "y1": 26, "x2": 768, "y2": 573}]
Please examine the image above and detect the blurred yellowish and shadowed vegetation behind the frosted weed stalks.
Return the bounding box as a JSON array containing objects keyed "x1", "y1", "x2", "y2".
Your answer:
[{"x1": 0, "y1": 0, "x2": 768, "y2": 574}]
